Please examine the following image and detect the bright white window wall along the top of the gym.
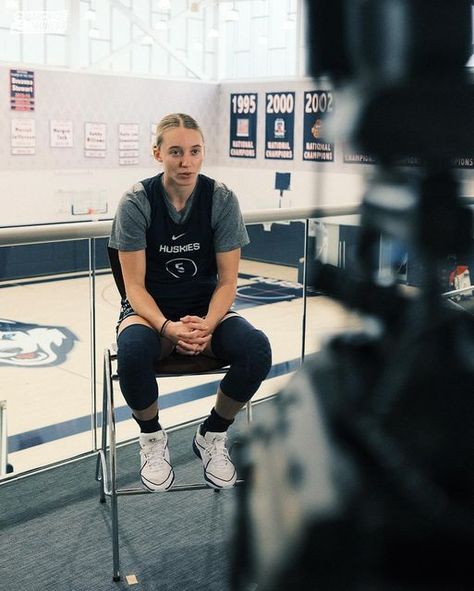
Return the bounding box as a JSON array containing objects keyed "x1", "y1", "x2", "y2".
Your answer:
[{"x1": 0, "y1": 0, "x2": 304, "y2": 80}]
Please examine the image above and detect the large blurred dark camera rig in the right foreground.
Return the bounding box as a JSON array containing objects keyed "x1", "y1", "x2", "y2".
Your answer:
[{"x1": 234, "y1": 0, "x2": 474, "y2": 591}]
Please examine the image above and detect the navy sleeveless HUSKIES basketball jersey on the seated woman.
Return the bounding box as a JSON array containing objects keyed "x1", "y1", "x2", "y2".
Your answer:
[{"x1": 142, "y1": 174, "x2": 217, "y2": 320}]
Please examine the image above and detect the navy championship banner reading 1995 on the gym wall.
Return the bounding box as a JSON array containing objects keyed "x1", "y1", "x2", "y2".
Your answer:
[{"x1": 229, "y1": 93, "x2": 258, "y2": 158}]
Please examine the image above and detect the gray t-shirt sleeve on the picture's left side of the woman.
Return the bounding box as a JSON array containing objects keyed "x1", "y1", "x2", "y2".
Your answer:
[{"x1": 109, "y1": 183, "x2": 151, "y2": 251}]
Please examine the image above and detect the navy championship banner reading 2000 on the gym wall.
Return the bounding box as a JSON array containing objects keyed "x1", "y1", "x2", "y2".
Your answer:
[{"x1": 265, "y1": 92, "x2": 295, "y2": 160}]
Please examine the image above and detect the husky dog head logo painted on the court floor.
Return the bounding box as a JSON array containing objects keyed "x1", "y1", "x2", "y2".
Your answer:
[{"x1": 0, "y1": 319, "x2": 77, "y2": 367}]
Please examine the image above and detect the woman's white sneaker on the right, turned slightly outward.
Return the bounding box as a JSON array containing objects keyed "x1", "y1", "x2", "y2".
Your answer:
[{"x1": 193, "y1": 426, "x2": 237, "y2": 488}]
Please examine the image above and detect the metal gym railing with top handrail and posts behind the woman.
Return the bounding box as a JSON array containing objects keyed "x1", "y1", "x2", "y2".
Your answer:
[{"x1": 0, "y1": 204, "x2": 358, "y2": 480}]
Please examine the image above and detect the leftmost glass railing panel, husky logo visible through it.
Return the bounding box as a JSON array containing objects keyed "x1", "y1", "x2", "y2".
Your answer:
[{"x1": 0, "y1": 240, "x2": 96, "y2": 473}]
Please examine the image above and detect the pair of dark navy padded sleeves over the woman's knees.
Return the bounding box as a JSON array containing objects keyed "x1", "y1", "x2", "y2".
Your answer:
[{"x1": 117, "y1": 315, "x2": 272, "y2": 410}]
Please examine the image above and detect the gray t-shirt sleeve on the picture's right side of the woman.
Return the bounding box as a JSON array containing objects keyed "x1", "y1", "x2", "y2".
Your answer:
[{"x1": 211, "y1": 181, "x2": 250, "y2": 252}]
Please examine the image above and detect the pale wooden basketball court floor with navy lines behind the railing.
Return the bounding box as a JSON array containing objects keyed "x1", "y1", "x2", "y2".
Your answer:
[{"x1": 0, "y1": 260, "x2": 358, "y2": 474}]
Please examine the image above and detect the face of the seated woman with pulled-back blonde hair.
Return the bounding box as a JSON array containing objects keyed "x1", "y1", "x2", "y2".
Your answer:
[{"x1": 155, "y1": 127, "x2": 204, "y2": 187}]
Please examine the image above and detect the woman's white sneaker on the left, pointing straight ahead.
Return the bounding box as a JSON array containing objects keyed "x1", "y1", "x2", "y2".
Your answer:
[{"x1": 140, "y1": 430, "x2": 174, "y2": 491}]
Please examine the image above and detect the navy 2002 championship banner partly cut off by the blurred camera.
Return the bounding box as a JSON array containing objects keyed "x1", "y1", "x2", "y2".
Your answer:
[{"x1": 303, "y1": 90, "x2": 334, "y2": 162}]
